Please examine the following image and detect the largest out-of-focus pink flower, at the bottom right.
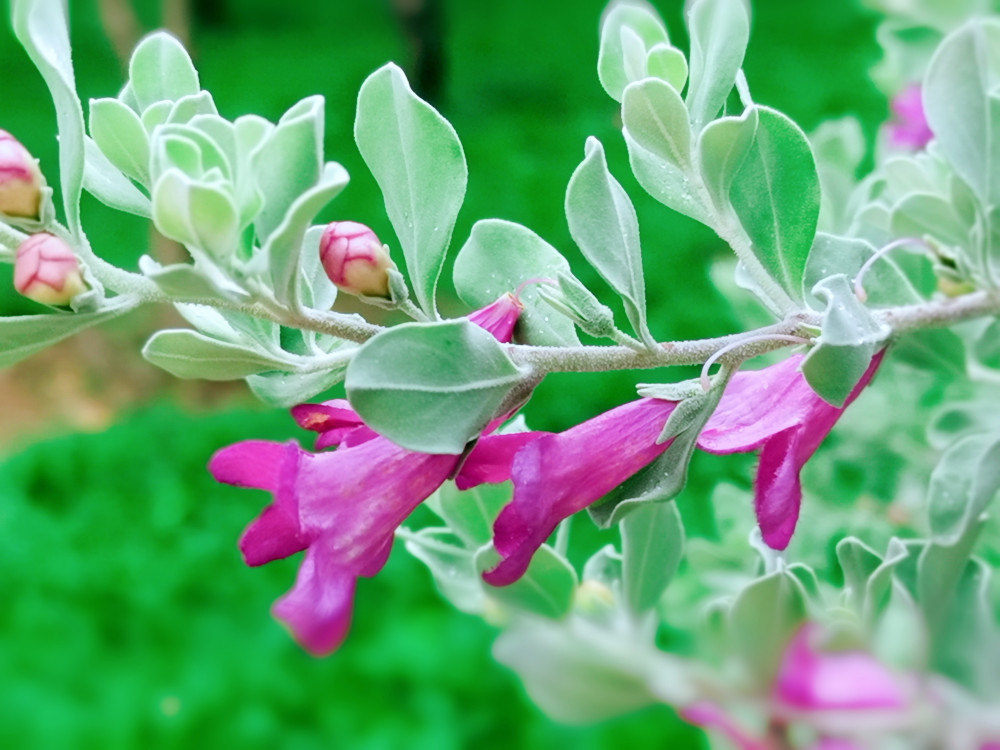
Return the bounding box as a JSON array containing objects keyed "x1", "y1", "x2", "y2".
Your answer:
[{"x1": 773, "y1": 624, "x2": 906, "y2": 712}]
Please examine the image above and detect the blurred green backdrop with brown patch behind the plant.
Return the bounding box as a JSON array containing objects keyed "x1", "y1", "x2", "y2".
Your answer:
[{"x1": 0, "y1": 0, "x2": 887, "y2": 750}]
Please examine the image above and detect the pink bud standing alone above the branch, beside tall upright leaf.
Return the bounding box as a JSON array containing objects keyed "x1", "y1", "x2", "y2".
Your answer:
[{"x1": 319, "y1": 221, "x2": 395, "y2": 297}]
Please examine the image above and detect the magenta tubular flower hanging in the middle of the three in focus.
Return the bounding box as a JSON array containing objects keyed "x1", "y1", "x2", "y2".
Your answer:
[{"x1": 477, "y1": 398, "x2": 676, "y2": 586}]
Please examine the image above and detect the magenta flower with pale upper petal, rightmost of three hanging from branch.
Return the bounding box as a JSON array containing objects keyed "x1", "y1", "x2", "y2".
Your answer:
[{"x1": 698, "y1": 352, "x2": 883, "y2": 549}]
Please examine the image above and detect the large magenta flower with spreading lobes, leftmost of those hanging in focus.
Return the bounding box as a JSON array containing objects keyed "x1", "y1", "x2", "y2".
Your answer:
[{"x1": 208, "y1": 290, "x2": 538, "y2": 655}]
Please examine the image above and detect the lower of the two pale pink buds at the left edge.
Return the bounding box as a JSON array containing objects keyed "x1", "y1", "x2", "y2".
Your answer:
[{"x1": 14, "y1": 232, "x2": 87, "y2": 305}]
